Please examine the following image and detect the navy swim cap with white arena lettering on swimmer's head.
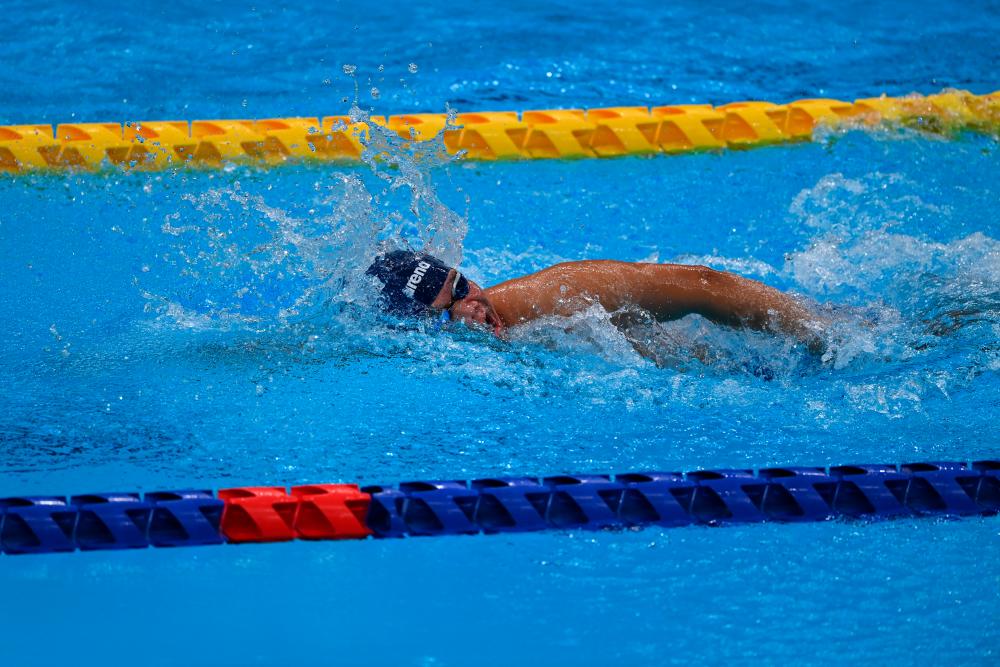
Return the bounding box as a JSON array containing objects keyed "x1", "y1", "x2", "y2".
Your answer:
[{"x1": 365, "y1": 250, "x2": 468, "y2": 315}]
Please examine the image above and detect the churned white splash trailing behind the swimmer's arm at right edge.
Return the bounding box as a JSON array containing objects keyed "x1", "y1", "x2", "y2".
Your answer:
[{"x1": 783, "y1": 173, "x2": 1000, "y2": 402}]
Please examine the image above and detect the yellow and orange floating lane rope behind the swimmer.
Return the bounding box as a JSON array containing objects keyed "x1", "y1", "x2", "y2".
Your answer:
[{"x1": 0, "y1": 90, "x2": 1000, "y2": 173}]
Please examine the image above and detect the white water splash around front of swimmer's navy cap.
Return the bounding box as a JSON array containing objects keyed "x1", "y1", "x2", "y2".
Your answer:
[{"x1": 140, "y1": 99, "x2": 467, "y2": 330}]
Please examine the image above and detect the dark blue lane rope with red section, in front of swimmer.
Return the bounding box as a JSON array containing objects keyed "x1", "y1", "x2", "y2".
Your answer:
[{"x1": 0, "y1": 460, "x2": 1000, "y2": 554}]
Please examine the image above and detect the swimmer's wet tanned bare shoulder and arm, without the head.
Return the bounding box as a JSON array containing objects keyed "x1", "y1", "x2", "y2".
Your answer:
[{"x1": 487, "y1": 260, "x2": 821, "y2": 349}]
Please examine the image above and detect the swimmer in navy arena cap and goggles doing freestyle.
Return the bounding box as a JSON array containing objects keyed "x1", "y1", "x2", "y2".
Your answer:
[{"x1": 367, "y1": 250, "x2": 826, "y2": 353}]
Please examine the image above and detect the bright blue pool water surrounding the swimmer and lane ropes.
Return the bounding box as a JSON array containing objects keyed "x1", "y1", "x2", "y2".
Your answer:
[{"x1": 0, "y1": 2, "x2": 1000, "y2": 665}]
